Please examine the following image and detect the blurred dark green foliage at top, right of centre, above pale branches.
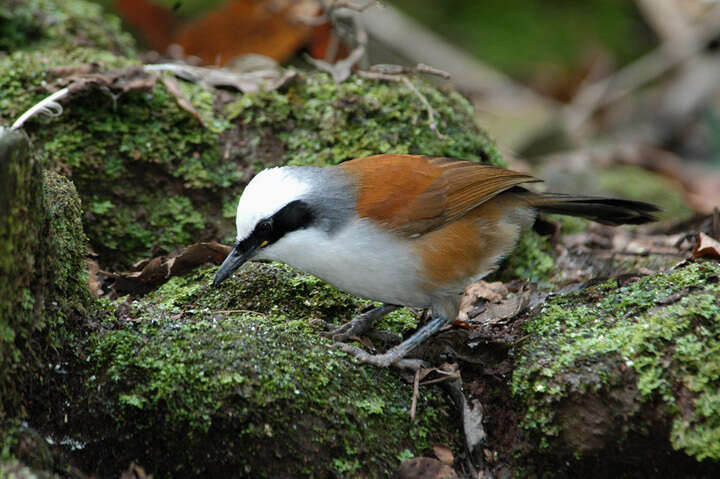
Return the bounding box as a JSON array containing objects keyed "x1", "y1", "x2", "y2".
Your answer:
[{"x1": 388, "y1": 0, "x2": 650, "y2": 76}]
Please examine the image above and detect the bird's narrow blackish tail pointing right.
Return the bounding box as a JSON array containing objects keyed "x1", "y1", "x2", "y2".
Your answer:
[{"x1": 528, "y1": 193, "x2": 660, "y2": 226}]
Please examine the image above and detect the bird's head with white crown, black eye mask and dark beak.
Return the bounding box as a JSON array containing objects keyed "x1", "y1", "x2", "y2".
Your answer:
[{"x1": 213, "y1": 167, "x2": 315, "y2": 286}]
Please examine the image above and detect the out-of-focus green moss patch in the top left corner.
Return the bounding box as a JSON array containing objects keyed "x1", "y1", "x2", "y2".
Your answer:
[{"x1": 0, "y1": 0, "x2": 135, "y2": 56}]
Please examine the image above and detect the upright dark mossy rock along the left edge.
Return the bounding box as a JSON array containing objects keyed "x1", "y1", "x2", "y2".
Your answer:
[{"x1": 0, "y1": 129, "x2": 89, "y2": 419}]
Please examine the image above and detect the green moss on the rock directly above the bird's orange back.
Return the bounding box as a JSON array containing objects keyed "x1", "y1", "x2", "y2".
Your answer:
[{"x1": 227, "y1": 73, "x2": 504, "y2": 166}]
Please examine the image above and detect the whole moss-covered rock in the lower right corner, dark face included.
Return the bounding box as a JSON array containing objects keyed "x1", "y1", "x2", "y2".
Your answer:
[{"x1": 512, "y1": 261, "x2": 720, "y2": 471}]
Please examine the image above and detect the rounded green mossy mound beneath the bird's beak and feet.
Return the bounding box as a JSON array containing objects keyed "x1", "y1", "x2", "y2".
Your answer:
[{"x1": 81, "y1": 264, "x2": 454, "y2": 477}]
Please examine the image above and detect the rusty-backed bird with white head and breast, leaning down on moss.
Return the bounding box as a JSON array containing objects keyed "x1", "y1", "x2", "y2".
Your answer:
[{"x1": 213, "y1": 154, "x2": 659, "y2": 367}]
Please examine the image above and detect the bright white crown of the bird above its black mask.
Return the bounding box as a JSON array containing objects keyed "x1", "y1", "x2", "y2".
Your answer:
[{"x1": 235, "y1": 167, "x2": 310, "y2": 241}]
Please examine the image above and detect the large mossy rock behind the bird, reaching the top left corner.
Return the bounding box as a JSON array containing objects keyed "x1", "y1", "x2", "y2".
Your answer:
[{"x1": 0, "y1": 0, "x2": 501, "y2": 269}]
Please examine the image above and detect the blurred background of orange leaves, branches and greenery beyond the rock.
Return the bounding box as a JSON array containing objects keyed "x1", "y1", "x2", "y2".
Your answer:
[{"x1": 93, "y1": 0, "x2": 720, "y2": 216}]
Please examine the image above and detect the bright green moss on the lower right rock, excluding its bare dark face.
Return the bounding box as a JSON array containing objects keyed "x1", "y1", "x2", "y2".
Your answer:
[{"x1": 512, "y1": 262, "x2": 720, "y2": 461}]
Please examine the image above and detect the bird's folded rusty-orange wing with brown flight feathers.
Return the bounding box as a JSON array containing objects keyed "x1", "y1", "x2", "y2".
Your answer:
[{"x1": 340, "y1": 155, "x2": 540, "y2": 236}]
